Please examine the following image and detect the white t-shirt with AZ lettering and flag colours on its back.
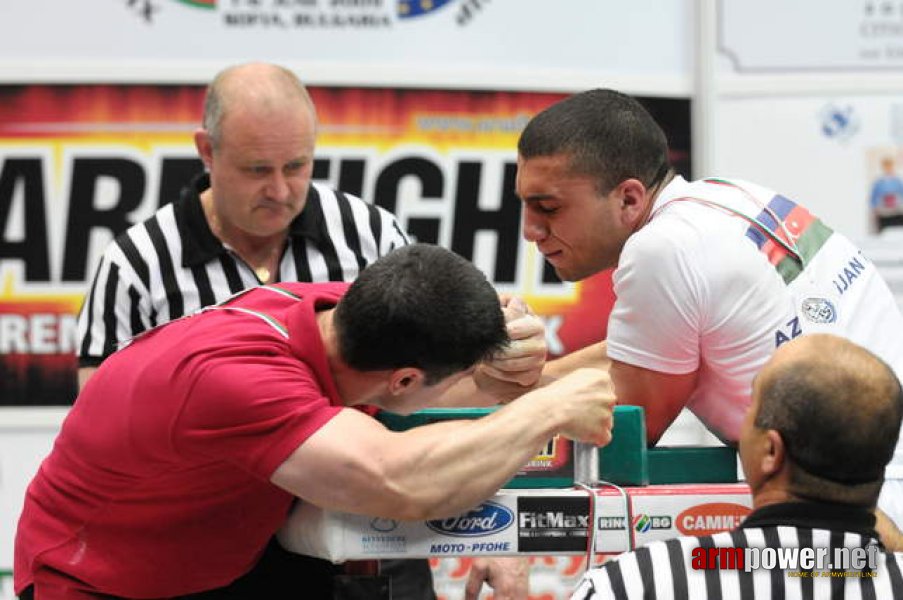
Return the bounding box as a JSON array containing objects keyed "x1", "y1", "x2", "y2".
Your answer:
[{"x1": 608, "y1": 177, "x2": 903, "y2": 478}]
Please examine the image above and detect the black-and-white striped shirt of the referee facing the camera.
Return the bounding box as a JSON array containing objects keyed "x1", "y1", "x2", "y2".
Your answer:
[{"x1": 78, "y1": 174, "x2": 409, "y2": 367}]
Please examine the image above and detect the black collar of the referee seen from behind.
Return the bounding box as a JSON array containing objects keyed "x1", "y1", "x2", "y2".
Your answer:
[{"x1": 740, "y1": 502, "x2": 878, "y2": 539}]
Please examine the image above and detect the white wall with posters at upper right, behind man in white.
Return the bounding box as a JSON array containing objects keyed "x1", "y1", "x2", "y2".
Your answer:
[{"x1": 708, "y1": 0, "x2": 903, "y2": 238}]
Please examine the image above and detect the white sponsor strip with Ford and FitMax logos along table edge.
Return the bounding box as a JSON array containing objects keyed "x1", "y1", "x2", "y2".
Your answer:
[{"x1": 279, "y1": 483, "x2": 752, "y2": 562}]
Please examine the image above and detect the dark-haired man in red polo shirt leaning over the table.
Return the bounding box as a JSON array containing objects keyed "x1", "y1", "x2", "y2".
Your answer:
[{"x1": 15, "y1": 245, "x2": 613, "y2": 598}]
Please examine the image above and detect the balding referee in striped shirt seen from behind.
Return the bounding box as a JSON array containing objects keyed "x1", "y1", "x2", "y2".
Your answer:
[{"x1": 572, "y1": 334, "x2": 903, "y2": 600}]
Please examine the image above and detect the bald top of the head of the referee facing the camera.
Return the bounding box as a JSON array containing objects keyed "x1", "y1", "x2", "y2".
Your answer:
[{"x1": 203, "y1": 63, "x2": 316, "y2": 149}]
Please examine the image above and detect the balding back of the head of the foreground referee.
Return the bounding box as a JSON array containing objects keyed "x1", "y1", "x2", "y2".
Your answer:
[{"x1": 754, "y1": 334, "x2": 903, "y2": 505}]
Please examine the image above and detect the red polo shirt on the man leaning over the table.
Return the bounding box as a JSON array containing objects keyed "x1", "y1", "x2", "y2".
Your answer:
[{"x1": 15, "y1": 283, "x2": 348, "y2": 598}]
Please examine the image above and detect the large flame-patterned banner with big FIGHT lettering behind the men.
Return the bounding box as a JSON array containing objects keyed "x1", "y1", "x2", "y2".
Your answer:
[{"x1": 0, "y1": 85, "x2": 689, "y2": 405}]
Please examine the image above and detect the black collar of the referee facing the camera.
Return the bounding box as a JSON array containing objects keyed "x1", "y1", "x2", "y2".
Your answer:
[{"x1": 173, "y1": 173, "x2": 324, "y2": 267}]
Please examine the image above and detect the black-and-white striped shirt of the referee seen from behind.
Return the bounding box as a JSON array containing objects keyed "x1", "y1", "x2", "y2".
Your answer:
[{"x1": 571, "y1": 502, "x2": 903, "y2": 600}]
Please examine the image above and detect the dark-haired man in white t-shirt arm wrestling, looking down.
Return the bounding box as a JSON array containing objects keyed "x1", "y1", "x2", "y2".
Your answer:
[{"x1": 517, "y1": 90, "x2": 903, "y2": 532}]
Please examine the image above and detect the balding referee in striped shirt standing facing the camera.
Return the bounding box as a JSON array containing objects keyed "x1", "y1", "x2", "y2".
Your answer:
[{"x1": 78, "y1": 63, "x2": 545, "y2": 600}]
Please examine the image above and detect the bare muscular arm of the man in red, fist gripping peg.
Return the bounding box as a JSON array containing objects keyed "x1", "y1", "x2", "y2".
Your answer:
[{"x1": 271, "y1": 369, "x2": 614, "y2": 520}]
